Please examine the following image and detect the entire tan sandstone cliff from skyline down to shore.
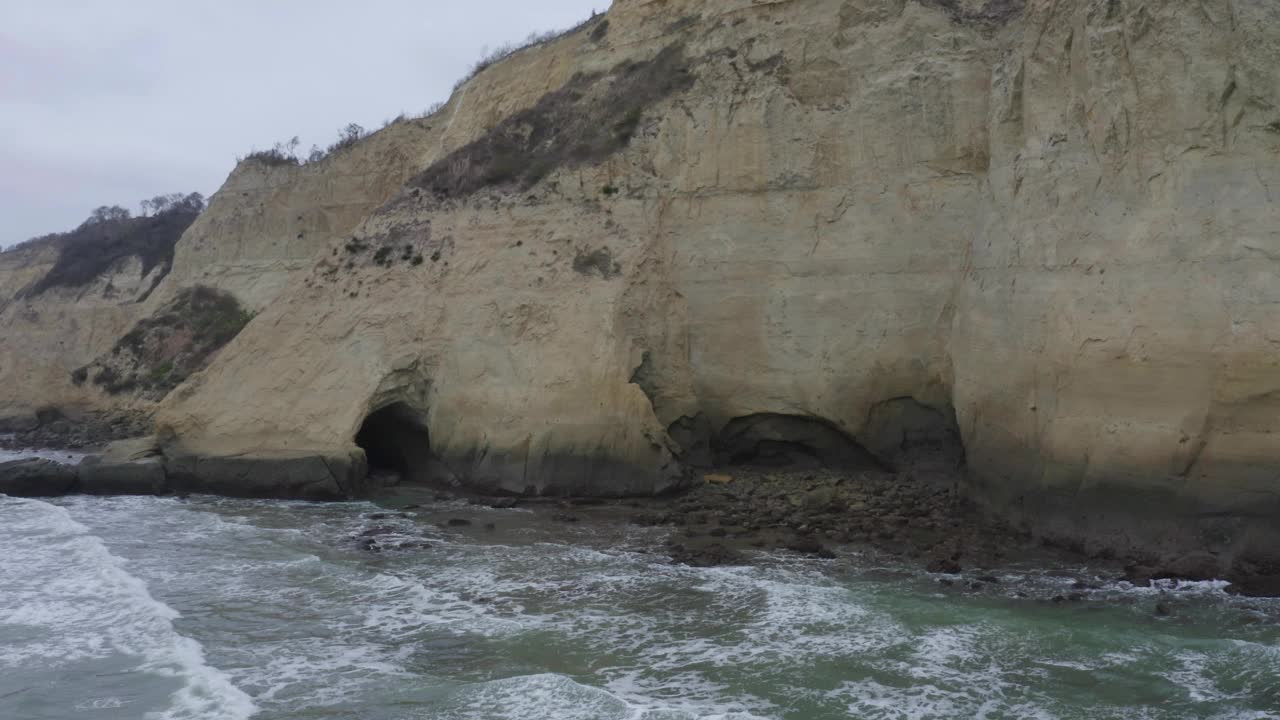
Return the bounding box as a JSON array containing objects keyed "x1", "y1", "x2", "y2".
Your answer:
[{"x1": 0, "y1": 0, "x2": 1280, "y2": 566}]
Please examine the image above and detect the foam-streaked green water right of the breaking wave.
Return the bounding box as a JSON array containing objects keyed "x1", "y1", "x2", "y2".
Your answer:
[{"x1": 22, "y1": 498, "x2": 1280, "y2": 720}]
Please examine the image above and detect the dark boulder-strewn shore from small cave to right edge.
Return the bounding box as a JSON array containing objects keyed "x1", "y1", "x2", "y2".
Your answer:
[{"x1": 380, "y1": 468, "x2": 1280, "y2": 602}]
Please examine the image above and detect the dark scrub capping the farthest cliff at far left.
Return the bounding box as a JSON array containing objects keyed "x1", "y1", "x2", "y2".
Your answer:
[{"x1": 23, "y1": 192, "x2": 205, "y2": 297}]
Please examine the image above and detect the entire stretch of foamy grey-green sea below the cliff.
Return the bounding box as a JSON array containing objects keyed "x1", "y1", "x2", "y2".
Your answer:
[{"x1": 0, "y1": 466, "x2": 1280, "y2": 720}]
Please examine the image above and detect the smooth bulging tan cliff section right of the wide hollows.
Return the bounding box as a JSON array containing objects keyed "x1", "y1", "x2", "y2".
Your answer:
[{"x1": 950, "y1": 1, "x2": 1280, "y2": 551}]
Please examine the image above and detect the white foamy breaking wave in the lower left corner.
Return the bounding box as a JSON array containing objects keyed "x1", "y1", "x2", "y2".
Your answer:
[{"x1": 0, "y1": 497, "x2": 256, "y2": 720}]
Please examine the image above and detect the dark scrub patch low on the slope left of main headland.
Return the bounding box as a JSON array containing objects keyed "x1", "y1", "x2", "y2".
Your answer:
[{"x1": 72, "y1": 287, "x2": 252, "y2": 400}]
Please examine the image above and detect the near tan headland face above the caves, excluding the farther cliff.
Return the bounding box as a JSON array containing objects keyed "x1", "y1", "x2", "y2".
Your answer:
[{"x1": 165, "y1": 0, "x2": 1280, "y2": 512}]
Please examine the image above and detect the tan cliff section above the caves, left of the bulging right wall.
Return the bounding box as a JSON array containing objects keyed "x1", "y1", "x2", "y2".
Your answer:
[{"x1": 154, "y1": 3, "x2": 995, "y2": 492}]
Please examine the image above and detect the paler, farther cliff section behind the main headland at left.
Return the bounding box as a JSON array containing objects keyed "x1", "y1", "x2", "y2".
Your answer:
[{"x1": 0, "y1": 117, "x2": 437, "y2": 428}]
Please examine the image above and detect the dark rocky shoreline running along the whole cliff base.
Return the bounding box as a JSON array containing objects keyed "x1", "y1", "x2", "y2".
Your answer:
[{"x1": 0, "y1": 436, "x2": 1280, "y2": 601}]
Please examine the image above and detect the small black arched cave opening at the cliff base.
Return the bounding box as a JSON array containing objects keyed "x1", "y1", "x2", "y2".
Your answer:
[{"x1": 356, "y1": 402, "x2": 443, "y2": 483}]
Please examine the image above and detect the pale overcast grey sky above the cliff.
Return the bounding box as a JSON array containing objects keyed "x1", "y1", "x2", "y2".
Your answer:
[{"x1": 0, "y1": 0, "x2": 609, "y2": 245}]
